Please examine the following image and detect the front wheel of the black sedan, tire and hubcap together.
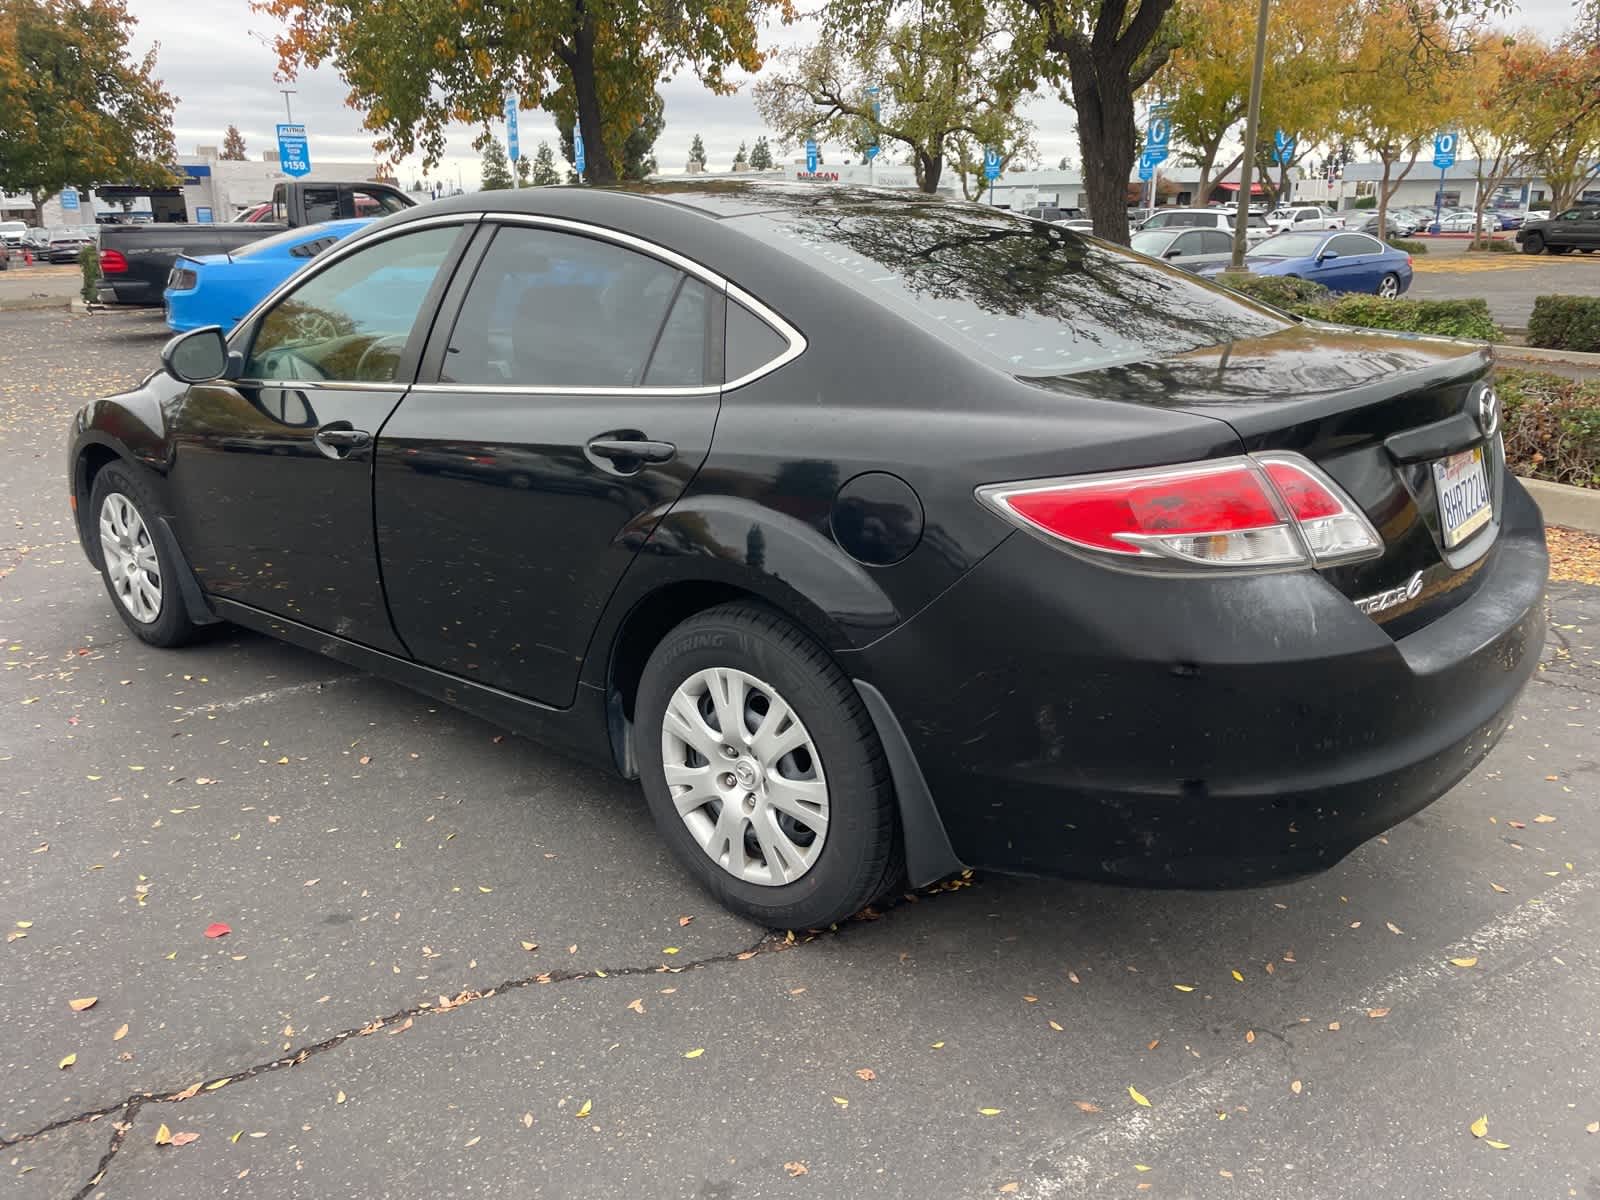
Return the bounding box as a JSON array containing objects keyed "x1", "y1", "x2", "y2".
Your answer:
[{"x1": 90, "y1": 462, "x2": 198, "y2": 646}]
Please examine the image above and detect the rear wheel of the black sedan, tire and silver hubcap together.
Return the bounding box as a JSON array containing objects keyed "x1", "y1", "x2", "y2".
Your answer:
[{"x1": 634, "y1": 605, "x2": 902, "y2": 930}]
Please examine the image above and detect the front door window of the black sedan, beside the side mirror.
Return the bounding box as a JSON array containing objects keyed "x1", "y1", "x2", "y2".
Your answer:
[{"x1": 243, "y1": 226, "x2": 459, "y2": 384}]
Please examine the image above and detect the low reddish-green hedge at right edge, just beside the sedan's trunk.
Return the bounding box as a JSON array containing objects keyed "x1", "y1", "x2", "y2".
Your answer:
[{"x1": 1496, "y1": 371, "x2": 1600, "y2": 488}]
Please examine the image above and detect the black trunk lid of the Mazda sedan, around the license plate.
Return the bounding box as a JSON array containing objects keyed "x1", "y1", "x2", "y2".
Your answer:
[{"x1": 1040, "y1": 322, "x2": 1506, "y2": 637}]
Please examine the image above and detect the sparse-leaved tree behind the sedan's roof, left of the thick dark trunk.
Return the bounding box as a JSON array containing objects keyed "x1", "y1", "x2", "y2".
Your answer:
[{"x1": 755, "y1": 0, "x2": 1026, "y2": 192}]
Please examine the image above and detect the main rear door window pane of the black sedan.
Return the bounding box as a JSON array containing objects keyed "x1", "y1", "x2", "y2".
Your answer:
[{"x1": 440, "y1": 226, "x2": 682, "y2": 387}]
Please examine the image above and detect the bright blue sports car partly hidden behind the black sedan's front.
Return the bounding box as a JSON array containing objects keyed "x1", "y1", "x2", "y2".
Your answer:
[{"x1": 163, "y1": 218, "x2": 373, "y2": 333}]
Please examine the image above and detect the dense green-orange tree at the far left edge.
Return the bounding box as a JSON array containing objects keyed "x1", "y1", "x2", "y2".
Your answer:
[{"x1": 0, "y1": 0, "x2": 176, "y2": 213}]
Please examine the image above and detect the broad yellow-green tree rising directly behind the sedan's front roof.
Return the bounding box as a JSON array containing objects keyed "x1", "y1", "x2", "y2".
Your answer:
[{"x1": 251, "y1": 0, "x2": 761, "y2": 184}]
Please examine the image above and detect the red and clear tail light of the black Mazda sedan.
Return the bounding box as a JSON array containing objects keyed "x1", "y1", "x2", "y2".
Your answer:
[{"x1": 978, "y1": 454, "x2": 1382, "y2": 570}]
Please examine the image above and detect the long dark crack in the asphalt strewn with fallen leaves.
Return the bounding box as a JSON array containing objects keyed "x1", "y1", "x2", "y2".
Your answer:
[{"x1": 0, "y1": 931, "x2": 787, "y2": 1200}]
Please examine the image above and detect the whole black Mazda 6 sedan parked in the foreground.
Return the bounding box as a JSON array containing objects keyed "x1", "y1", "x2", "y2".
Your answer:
[{"x1": 67, "y1": 182, "x2": 1546, "y2": 926}]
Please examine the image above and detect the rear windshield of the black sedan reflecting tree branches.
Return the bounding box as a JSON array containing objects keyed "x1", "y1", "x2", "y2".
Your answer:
[{"x1": 734, "y1": 202, "x2": 1288, "y2": 374}]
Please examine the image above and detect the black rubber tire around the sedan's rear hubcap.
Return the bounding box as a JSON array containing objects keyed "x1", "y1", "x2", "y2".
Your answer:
[{"x1": 634, "y1": 603, "x2": 904, "y2": 930}]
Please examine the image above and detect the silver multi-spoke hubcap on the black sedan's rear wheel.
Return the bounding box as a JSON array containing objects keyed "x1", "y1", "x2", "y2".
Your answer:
[{"x1": 661, "y1": 667, "x2": 827, "y2": 886}]
